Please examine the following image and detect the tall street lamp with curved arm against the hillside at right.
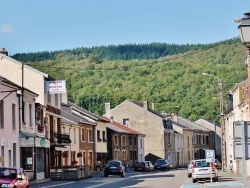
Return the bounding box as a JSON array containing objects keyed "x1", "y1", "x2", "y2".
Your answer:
[{"x1": 202, "y1": 73, "x2": 227, "y2": 171}]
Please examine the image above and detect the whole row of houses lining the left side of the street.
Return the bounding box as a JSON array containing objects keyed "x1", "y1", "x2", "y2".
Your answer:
[{"x1": 0, "y1": 49, "x2": 221, "y2": 180}]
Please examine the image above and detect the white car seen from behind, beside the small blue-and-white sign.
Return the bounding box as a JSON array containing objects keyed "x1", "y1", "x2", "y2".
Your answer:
[{"x1": 192, "y1": 159, "x2": 218, "y2": 183}]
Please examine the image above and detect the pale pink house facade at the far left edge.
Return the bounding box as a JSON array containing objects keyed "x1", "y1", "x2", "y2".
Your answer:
[{"x1": 0, "y1": 76, "x2": 20, "y2": 167}]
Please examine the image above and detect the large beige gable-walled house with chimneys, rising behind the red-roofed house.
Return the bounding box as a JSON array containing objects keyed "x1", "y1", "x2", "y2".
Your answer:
[{"x1": 104, "y1": 100, "x2": 166, "y2": 162}]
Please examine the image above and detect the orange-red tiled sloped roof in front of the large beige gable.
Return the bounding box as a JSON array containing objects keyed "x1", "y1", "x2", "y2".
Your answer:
[{"x1": 102, "y1": 116, "x2": 142, "y2": 135}]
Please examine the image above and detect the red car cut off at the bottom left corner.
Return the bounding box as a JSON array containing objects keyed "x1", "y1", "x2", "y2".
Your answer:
[{"x1": 0, "y1": 167, "x2": 29, "y2": 188}]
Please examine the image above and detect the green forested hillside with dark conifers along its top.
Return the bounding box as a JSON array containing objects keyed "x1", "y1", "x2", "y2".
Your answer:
[{"x1": 13, "y1": 39, "x2": 247, "y2": 122}]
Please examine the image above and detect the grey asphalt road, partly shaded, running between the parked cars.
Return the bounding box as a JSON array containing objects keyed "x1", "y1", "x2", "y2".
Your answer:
[{"x1": 30, "y1": 169, "x2": 245, "y2": 188}]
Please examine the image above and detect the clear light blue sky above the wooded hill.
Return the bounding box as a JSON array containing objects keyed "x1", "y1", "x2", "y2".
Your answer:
[{"x1": 0, "y1": 0, "x2": 250, "y2": 55}]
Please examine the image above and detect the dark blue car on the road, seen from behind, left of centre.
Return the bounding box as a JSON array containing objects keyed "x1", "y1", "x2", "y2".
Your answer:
[{"x1": 104, "y1": 160, "x2": 125, "y2": 177}]
